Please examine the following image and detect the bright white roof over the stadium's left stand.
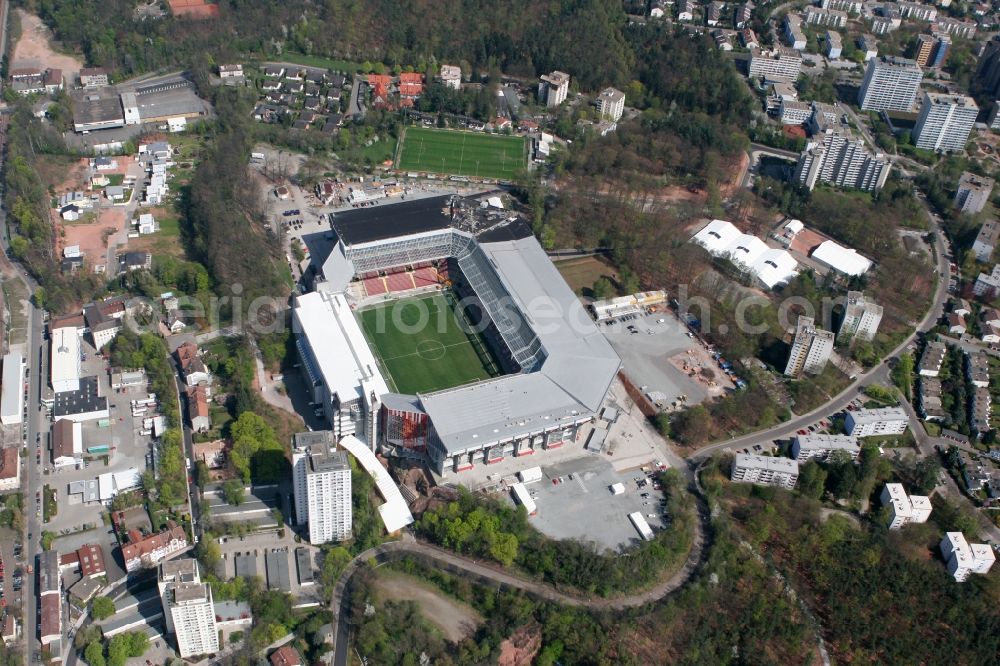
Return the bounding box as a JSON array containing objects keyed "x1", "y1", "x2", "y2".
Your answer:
[{"x1": 295, "y1": 291, "x2": 389, "y2": 402}]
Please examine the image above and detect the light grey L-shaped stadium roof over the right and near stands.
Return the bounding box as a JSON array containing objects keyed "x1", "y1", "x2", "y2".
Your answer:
[{"x1": 420, "y1": 231, "x2": 621, "y2": 455}]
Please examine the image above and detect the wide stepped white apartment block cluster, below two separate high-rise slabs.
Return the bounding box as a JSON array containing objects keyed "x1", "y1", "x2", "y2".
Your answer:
[{"x1": 794, "y1": 126, "x2": 891, "y2": 192}]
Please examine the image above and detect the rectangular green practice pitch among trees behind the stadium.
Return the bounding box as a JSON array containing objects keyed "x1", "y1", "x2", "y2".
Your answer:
[{"x1": 396, "y1": 127, "x2": 527, "y2": 180}]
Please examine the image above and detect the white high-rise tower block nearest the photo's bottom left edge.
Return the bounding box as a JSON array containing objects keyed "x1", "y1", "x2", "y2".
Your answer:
[{"x1": 157, "y1": 559, "x2": 219, "y2": 659}]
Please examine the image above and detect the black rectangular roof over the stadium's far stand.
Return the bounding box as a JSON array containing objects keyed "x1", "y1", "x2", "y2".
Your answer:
[{"x1": 324, "y1": 195, "x2": 451, "y2": 245}]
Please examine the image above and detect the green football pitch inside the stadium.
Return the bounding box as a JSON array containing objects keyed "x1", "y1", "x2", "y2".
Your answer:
[{"x1": 358, "y1": 294, "x2": 501, "y2": 394}]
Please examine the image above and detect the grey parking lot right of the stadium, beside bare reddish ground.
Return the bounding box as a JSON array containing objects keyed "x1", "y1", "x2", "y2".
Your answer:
[{"x1": 599, "y1": 313, "x2": 709, "y2": 406}]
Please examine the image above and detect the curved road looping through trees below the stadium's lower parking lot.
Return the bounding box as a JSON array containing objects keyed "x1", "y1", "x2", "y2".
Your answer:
[{"x1": 330, "y1": 494, "x2": 709, "y2": 666}]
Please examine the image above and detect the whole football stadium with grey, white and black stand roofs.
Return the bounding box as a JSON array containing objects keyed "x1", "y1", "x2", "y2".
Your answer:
[{"x1": 293, "y1": 196, "x2": 621, "y2": 474}]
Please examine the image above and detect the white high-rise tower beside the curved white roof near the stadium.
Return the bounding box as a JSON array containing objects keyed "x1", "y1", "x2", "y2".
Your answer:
[{"x1": 292, "y1": 431, "x2": 352, "y2": 544}]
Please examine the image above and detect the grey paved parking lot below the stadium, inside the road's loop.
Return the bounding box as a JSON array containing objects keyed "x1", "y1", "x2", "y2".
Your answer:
[{"x1": 528, "y1": 455, "x2": 663, "y2": 551}]
